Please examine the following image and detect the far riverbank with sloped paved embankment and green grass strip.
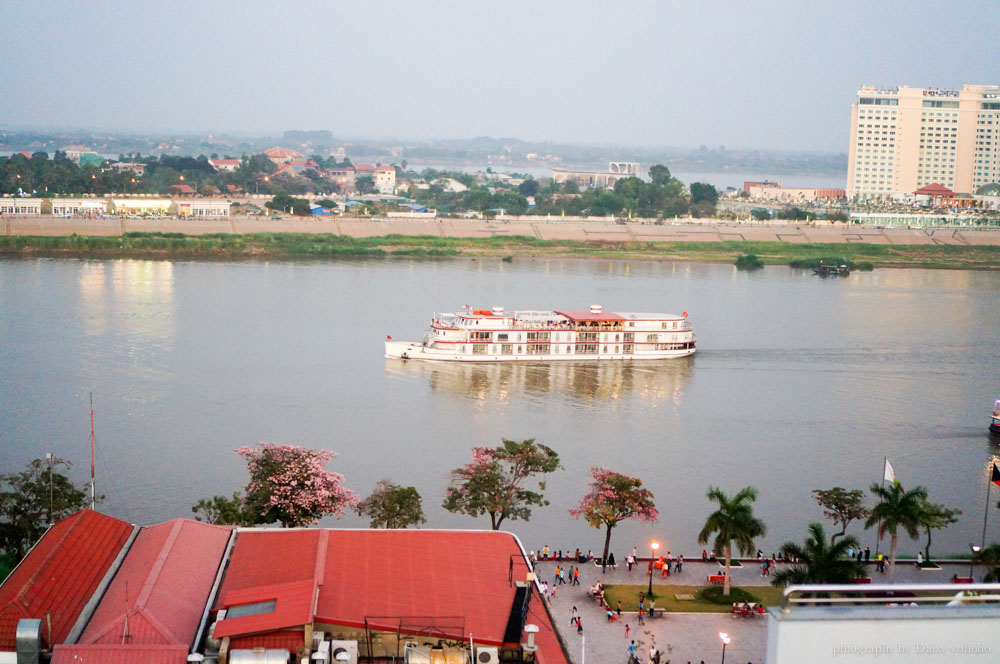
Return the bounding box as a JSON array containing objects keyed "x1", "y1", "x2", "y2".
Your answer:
[{"x1": 0, "y1": 216, "x2": 1000, "y2": 270}]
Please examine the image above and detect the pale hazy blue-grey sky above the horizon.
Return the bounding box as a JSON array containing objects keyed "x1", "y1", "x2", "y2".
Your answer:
[{"x1": 0, "y1": 0, "x2": 1000, "y2": 152}]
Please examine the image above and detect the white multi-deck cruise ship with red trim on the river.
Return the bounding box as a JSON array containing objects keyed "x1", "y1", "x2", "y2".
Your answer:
[{"x1": 385, "y1": 304, "x2": 695, "y2": 362}]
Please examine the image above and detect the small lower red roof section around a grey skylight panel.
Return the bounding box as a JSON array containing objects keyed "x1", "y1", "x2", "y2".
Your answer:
[{"x1": 215, "y1": 579, "x2": 316, "y2": 639}]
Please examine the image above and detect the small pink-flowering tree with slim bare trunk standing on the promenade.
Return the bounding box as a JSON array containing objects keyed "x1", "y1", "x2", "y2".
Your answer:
[{"x1": 569, "y1": 468, "x2": 660, "y2": 560}]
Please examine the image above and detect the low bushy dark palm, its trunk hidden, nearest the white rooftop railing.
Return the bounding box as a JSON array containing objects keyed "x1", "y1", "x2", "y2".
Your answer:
[{"x1": 771, "y1": 523, "x2": 863, "y2": 586}]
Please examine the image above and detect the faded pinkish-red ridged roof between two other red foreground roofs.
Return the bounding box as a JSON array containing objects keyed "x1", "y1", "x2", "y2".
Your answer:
[{"x1": 79, "y1": 519, "x2": 232, "y2": 645}]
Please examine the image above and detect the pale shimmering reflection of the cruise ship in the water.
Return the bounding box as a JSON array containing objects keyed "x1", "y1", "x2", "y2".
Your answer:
[{"x1": 385, "y1": 357, "x2": 694, "y2": 405}]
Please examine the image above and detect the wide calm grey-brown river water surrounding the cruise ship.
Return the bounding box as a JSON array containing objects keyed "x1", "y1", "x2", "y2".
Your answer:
[{"x1": 0, "y1": 259, "x2": 1000, "y2": 555}]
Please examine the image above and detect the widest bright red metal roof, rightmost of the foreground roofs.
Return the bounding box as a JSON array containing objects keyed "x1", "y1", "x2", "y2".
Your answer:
[{"x1": 216, "y1": 530, "x2": 562, "y2": 648}]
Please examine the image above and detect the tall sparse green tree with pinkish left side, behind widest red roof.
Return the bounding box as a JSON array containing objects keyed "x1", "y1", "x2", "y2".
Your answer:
[{"x1": 442, "y1": 438, "x2": 561, "y2": 530}]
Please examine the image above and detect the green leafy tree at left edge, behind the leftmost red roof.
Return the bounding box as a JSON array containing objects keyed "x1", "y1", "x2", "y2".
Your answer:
[{"x1": 0, "y1": 458, "x2": 89, "y2": 560}]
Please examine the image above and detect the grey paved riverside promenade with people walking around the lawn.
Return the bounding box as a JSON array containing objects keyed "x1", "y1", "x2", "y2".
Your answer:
[{"x1": 537, "y1": 556, "x2": 969, "y2": 664}]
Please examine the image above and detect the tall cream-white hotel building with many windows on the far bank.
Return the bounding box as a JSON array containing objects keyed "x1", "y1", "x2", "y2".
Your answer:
[{"x1": 847, "y1": 85, "x2": 1000, "y2": 198}]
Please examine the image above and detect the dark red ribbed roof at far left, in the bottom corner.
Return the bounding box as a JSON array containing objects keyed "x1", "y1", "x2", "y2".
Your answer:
[{"x1": 0, "y1": 509, "x2": 132, "y2": 651}]
